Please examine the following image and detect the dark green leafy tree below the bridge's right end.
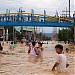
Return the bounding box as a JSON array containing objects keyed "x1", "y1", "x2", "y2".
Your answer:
[{"x1": 58, "y1": 26, "x2": 74, "y2": 42}]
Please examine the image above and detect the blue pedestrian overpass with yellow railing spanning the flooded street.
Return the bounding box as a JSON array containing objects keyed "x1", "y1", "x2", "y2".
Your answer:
[{"x1": 0, "y1": 9, "x2": 74, "y2": 27}]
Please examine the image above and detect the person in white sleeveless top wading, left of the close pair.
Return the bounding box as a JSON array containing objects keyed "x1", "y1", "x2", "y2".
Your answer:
[{"x1": 28, "y1": 41, "x2": 39, "y2": 63}]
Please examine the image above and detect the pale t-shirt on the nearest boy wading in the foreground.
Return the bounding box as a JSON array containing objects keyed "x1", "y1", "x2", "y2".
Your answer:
[{"x1": 57, "y1": 54, "x2": 67, "y2": 72}]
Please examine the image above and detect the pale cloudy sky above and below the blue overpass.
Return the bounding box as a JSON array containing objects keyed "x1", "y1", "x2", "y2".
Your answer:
[{"x1": 0, "y1": 0, "x2": 75, "y2": 32}]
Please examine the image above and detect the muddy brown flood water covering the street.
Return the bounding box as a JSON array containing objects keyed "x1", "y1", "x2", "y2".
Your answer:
[{"x1": 0, "y1": 42, "x2": 75, "y2": 75}]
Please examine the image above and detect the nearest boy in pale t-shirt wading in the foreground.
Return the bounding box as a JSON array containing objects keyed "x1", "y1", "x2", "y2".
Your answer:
[{"x1": 52, "y1": 44, "x2": 69, "y2": 73}]
